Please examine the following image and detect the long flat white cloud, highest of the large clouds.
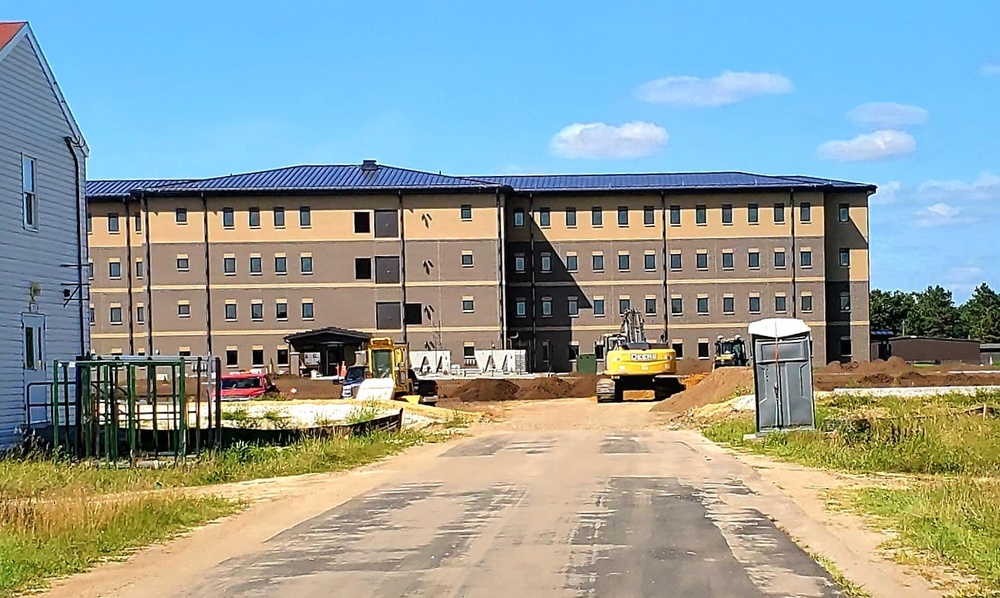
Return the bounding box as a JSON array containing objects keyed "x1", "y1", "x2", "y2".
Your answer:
[{"x1": 637, "y1": 71, "x2": 793, "y2": 107}]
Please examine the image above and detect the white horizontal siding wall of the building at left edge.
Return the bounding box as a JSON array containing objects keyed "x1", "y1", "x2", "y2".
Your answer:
[{"x1": 0, "y1": 38, "x2": 90, "y2": 447}]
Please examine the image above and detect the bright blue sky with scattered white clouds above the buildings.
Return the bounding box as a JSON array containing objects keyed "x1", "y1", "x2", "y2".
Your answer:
[{"x1": 7, "y1": 0, "x2": 1000, "y2": 300}]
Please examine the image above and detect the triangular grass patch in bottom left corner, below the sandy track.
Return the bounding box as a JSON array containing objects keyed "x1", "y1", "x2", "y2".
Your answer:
[{"x1": 0, "y1": 492, "x2": 239, "y2": 596}]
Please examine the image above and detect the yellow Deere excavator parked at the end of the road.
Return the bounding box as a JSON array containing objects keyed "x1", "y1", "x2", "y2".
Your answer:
[{"x1": 597, "y1": 309, "x2": 684, "y2": 403}]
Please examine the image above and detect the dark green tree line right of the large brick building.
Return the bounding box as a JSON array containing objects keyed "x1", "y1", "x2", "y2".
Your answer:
[{"x1": 871, "y1": 283, "x2": 1000, "y2": 343}]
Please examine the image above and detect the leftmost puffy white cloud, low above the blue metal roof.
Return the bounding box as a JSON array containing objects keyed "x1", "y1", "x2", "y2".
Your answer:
[{"x1": 551, "y1": 121, "x2": 669, "y2": 159}]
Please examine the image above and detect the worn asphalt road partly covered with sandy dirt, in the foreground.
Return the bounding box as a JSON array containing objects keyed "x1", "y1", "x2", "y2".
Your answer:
[{"x1": 184, "y1": 429, "x2": 844, "y2": 598}]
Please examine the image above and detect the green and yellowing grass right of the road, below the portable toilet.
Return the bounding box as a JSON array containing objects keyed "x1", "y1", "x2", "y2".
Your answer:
[{"x1": 703, "y1": 394, "x2": 1000, "y2": 596}]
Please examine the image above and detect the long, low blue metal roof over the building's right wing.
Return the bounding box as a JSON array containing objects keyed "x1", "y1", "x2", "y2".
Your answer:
[{"x1": 472, "y1": 172, "x2": 874, "y2": 191}]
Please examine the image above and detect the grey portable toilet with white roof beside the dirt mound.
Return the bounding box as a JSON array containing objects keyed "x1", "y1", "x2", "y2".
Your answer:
[{"x1": 748, "y1": 318, "x2": 816, "y2": 434}]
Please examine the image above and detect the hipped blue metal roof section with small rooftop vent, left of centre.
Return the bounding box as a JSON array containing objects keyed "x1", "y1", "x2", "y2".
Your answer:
[{"x1": 150, "y1": 164, "x2": 500, "y2": 193}]
